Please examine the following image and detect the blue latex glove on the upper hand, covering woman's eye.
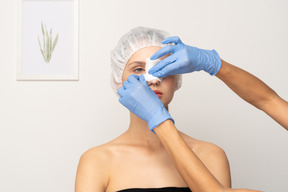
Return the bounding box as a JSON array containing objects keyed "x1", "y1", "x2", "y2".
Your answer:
[{"x1": 148, "y1": 36, "x2": 222, "y2": 78}]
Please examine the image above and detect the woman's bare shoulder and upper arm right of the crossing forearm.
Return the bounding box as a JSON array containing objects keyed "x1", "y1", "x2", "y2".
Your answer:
[{"x1": 179, "y1": 131, "x2": 231, "y2": 187}]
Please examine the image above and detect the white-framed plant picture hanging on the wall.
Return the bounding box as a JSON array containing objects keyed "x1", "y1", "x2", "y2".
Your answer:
[{"x1": 17, "y1": 0, "x2": 79, "y2": 80}]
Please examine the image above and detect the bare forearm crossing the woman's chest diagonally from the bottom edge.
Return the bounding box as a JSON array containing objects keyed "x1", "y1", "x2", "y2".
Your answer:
[{"x1": 154, "y1": 120, "x2": 259, "y2": 192}]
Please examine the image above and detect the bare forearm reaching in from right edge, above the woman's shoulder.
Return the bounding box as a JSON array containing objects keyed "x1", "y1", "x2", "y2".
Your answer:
[{"x1": 215, "y1": 60, "x2": 288, "y2": 130}]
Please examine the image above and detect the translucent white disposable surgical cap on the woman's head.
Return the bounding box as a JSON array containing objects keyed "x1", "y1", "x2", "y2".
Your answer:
[{"x1": 110, "y1": 26, "x2": 182, "y2": 97}]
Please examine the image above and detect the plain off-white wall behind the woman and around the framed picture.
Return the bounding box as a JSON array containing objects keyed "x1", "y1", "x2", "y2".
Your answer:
[{"x1": 0, "y1": 0, "x2": 288, "y2": 192}]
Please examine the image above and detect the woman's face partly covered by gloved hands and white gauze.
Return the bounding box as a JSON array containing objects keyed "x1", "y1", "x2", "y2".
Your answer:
[{"x1": 122, "y1": 46, "x2": 176, "y2": 108}]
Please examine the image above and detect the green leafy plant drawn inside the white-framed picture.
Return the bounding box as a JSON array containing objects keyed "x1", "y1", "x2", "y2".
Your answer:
[{"x1": 38, "y1": 21, "x2": 58, "y2": 63}]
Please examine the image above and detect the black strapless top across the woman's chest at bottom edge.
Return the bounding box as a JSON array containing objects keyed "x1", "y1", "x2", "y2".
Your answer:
[{"x1": 116, "y1": 187, "x2": 191, "y2": 192}]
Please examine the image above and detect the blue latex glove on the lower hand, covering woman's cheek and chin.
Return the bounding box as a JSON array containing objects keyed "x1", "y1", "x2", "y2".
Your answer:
[{"x1": 117, "y1": 74, "x2": 175, "y2": 134}]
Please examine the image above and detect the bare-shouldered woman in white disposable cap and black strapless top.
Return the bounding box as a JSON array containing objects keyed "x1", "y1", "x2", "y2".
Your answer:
[{"x1": 75, "y1": 27, "x2": 231, "y2": 192}]
